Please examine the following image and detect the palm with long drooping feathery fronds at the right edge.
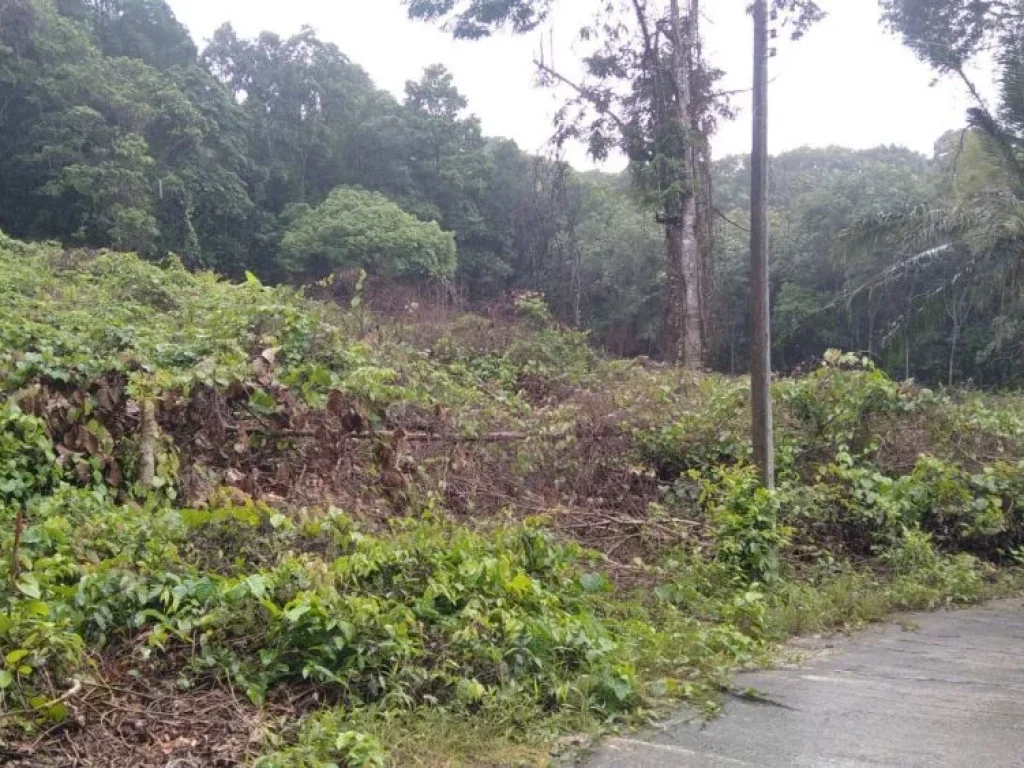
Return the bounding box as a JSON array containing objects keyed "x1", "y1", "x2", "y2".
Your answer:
[{"x1": 837, "y1": 35, "x2": 1024, "y2": 385}]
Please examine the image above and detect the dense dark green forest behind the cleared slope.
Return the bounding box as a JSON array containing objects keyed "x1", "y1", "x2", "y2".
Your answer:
[{"x1": 0, "y1": 0, "x2": 1024, "y2": 385}]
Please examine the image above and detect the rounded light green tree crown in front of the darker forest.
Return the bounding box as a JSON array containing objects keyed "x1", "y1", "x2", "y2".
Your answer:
[{"x1": 281, "y1": 186, "x2": 456, "y2": 280}]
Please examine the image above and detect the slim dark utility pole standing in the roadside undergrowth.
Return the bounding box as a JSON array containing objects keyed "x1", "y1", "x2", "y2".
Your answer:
[{"x1": 751, "y1": 0, "x2": 775, "y2": 488}]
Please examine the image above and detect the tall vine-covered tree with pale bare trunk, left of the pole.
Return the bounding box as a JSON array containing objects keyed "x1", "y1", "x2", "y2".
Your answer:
[{"x1": 407, "y1": 0, "x2": 717, "y2": 368}]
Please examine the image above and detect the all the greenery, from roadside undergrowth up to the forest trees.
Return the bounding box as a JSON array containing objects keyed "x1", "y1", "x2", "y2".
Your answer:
[{"x1": 6, "y1": 0, "x2": 1024, "y2": 768}]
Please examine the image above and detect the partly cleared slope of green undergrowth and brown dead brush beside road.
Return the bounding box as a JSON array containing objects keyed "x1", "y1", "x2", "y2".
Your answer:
[{"x1": 0, "y1": 239, "x2": 1024, "y2": 767}]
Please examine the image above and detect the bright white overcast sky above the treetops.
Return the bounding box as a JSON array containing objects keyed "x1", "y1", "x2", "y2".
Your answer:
[{"x1": 169, "y1": 0, "x2": 991, "y2": 168}]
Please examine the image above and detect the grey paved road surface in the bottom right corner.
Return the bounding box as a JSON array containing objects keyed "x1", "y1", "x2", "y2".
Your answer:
[{"x1": 589, "y1": 600, "x2": 1024, "y2": 768}]
